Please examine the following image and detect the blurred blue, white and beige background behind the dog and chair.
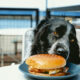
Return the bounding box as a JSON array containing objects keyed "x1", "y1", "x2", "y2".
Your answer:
[{"x1": 0, "y1": 0, "x2": 80, "y2": 67}]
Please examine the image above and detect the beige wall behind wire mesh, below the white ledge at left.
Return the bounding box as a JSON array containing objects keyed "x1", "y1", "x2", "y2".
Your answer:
[{"x1": 0, "y1": 35, "x2": 22, "y2": 54}]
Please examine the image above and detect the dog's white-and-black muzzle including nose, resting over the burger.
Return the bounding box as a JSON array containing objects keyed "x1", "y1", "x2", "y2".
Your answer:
[{"x1": 48, "y1": 44, "x2": 69, "y2": 60}]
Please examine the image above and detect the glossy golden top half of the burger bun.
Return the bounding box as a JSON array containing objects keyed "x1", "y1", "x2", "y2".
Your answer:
[{"x1": 25, "y1": 54, "x2": 66, "y2": 69}]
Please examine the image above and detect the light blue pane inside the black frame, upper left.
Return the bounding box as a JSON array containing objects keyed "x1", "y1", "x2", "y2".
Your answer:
[{"x1": 0, "y1": 16, "x2": 32, "y2": 29}]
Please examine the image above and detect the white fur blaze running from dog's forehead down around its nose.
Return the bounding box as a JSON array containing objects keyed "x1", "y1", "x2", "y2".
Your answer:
[{"x1": 48, "y1": 23, "x2": 71, "y2": 57}]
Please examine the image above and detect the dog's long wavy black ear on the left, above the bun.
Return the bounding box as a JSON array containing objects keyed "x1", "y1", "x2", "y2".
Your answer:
[{"x1": 31, "y1": 20, "x2": 49, "y2": 55}]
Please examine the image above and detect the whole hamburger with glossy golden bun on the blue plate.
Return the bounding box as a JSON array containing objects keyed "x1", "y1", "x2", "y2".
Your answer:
[{"x1": 25, "y1": 54, "x2": 69, "y2": 76}]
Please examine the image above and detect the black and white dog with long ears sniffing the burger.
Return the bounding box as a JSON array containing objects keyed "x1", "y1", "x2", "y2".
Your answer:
[{"x1": 31, "y1": 19, "x2": 80, "y2": 64}]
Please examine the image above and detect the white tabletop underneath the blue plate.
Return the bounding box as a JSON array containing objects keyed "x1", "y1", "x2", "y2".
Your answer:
[{"x1": 0, "y1": 64, "x2": 80, "y2": 80}]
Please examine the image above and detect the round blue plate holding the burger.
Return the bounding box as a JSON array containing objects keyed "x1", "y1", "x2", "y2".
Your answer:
[{"x1": 19, "y1": 62, "x2": 80, "y2": 80}]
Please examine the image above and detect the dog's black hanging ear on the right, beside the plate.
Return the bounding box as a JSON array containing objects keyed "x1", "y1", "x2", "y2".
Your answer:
[{"x1": 68, "y1": 24, "x2": 80, "y2": 64}]
